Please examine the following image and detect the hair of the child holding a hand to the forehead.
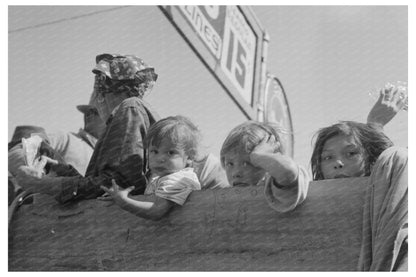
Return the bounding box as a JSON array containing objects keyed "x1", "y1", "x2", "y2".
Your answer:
[{"x1": 220, "y1": 120, "x2": 283, "y2": 167}]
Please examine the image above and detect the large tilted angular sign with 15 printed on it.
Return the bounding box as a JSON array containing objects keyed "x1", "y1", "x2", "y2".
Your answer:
[{"x1": 161, "y1": 5, "x2": 264, "y2": 119}]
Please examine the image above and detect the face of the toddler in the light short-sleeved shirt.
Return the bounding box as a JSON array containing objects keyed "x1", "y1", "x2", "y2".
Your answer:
[{"x1": 149, "y1": 139, "x2": 189, "y2": 176}]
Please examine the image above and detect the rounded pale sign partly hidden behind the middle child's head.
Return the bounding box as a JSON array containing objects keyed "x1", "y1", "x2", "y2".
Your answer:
[{"x1": 264, "y1": 75, "x2": 294, "y2": 157}]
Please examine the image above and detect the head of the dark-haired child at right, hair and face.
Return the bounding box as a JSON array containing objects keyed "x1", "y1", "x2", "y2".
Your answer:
[{"x1": 311, "y1": 121, "x2": 393, "y2": 180}]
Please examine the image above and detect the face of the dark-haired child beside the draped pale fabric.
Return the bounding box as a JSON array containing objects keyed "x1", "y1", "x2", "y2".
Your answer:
[{"x1": 321, "y1": 135, "x2": 365, "y2": 179}]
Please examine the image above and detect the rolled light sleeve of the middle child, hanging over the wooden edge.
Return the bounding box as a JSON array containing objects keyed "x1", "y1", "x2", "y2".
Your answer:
[{"x1": 264, "y1": 166, "x2": 310, "y2": 213}]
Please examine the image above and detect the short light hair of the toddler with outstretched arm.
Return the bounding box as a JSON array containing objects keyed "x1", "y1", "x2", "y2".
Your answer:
[{"x1": 144, "y1": 115, "x2": 201, "y2": 160}]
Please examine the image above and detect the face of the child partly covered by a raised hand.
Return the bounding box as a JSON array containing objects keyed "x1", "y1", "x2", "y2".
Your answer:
[{"x1": 224, "y1": 152, "x2": 266, "y2": 186}]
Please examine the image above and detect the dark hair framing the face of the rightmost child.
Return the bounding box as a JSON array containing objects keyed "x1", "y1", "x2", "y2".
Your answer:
[{"x1": 310, "y1": 121, "x2": 393, "y2": 180}]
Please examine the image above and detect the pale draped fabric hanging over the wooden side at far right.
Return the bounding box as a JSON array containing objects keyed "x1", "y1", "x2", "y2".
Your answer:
[{"x1": 358, "y1": 147, "x2": 408, "y2": 271}]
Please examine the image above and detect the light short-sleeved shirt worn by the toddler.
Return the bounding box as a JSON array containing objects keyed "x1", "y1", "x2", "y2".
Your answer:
[{"x1": 144, "y1": 167, "x2": 201, "y2": 205}]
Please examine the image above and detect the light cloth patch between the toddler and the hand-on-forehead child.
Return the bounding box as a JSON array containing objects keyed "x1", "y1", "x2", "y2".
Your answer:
[{"x1": 192, "y1": 153, "x2": 231, "y2": 189}]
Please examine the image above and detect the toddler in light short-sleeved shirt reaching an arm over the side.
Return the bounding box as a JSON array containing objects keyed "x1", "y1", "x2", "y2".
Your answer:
[{"x1": 101, "y1": 116, "x2": 201, "y2": 220}]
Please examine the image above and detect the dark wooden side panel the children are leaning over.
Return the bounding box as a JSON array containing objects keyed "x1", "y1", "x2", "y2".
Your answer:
[{"x1": 9, "y1": 178, "x2": 367, "y2": 271}]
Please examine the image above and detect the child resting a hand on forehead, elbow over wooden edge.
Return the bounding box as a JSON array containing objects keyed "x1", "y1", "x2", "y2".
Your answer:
[{"x1": 220, "y1": 121, "x2": 309, "y2": 212}]
